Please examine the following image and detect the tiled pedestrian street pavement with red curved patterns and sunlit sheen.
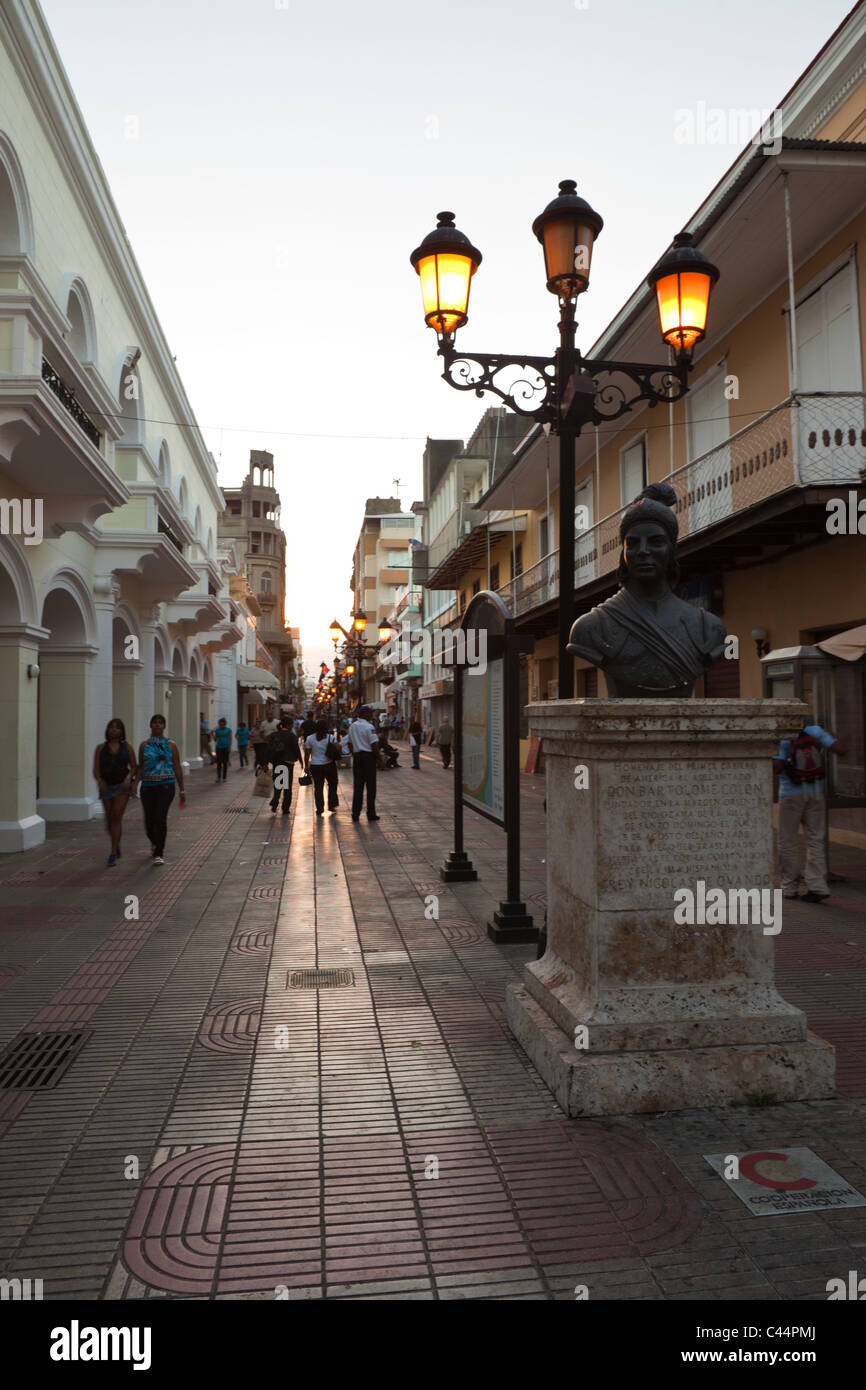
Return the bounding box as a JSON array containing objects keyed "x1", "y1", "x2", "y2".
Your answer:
[{"x1": 0, "y1": 756, "x2": 866, "y2": 1300}]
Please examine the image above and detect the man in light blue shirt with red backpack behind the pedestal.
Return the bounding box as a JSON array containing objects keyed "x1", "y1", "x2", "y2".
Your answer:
[{"x1": 773, "y1": 724, "x2": 847, "y2": 902}]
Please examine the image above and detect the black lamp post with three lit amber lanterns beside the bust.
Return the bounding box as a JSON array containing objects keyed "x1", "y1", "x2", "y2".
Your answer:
[{"x1": 410, "y1": 187, "x2": 719, "y2": 699}]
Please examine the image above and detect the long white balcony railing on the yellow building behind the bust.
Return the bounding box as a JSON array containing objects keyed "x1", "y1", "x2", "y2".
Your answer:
[{"x1": 498, "y1": 392, "x2": 866, "y2": 617}]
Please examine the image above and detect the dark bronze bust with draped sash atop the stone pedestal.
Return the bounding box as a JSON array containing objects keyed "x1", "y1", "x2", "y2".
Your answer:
[{"x1": 567, "y1": 482, "x2": 726, "y2": 699}]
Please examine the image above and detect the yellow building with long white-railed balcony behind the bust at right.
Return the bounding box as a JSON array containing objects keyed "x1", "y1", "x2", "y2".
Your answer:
[{"x1": 475, "y1": 6, "x2": 866, "y2": 796}]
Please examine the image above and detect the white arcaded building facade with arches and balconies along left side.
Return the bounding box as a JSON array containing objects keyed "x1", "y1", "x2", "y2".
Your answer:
[{"x1": 0, "y1": 0, "x2": 242, "y2": 852}]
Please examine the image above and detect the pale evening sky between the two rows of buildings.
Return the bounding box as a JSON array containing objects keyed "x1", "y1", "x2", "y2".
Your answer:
[{"x1": 42, "y1": 0, "x2": 852, "y2": 670}]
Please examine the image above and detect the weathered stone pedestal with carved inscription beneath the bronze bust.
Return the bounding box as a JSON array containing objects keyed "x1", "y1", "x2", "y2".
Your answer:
[{"x1": 507, "y1": 699, "x2": 835, "y2": 1115}]
